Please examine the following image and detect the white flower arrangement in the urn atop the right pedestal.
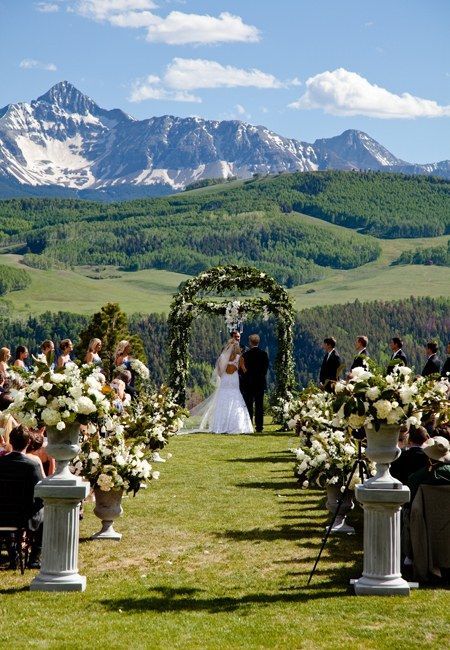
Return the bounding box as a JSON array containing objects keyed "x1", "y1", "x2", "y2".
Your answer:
[{"x1": 333, "y1": 366, "x2": 449, "y2": 431}]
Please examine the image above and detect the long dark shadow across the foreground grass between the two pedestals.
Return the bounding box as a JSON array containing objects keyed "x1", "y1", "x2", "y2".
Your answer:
[{"x1": 100, "y1": 569, "x2": 348, "y2": 614}]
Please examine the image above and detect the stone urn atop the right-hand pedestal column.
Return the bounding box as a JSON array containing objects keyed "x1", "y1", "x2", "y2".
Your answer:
[{"x1": 364, "y1": 424, "x2": 401, "y2": 490}]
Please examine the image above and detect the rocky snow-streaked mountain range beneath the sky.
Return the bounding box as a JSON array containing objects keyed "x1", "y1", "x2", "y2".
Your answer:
[{"x1": 0, "y1": 81, "x2": 450, "y2": 199}]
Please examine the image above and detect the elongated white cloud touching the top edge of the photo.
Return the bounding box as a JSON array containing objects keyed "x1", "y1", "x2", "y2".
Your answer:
[{"x1": 69, "y1": 0, "x2": 260, "y2": 45}]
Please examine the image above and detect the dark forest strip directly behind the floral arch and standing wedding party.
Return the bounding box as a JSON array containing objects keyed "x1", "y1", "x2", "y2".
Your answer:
[{"x1": 0, "y1": 298, "x2": 450, "y2": 389}]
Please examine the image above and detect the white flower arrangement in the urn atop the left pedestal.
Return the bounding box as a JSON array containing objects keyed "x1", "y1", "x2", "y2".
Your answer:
[{"x1": 8, "y1": 362, "x2": 111, "y2": 431}]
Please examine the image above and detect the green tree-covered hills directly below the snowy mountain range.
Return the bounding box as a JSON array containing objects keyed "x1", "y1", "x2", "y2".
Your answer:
[{"x1": 0, "y1": 171, "x2": 450, "y2": 287}]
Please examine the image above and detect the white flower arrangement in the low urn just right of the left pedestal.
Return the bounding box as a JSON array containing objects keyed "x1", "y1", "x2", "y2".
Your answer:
[{"x1": 74, "y1": 435, "x2": 159, "y2": 494}]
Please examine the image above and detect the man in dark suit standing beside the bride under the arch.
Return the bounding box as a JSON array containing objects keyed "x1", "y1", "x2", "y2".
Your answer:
[{"x1": 241, "y1": 334, "x2": 269, "y2": 433}]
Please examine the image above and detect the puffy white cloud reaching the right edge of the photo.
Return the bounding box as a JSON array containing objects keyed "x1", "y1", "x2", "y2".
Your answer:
[{"x1": 289, "y1": 68, "x2": 450, "y2": 119}]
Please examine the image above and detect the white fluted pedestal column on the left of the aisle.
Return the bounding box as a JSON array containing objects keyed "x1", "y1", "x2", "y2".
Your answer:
[{"x1": 30, "y1": 476, "x2": 90, "y2": 591}]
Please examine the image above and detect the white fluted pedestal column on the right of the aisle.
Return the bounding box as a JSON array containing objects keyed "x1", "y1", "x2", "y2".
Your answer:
[{"x1": 354, "y1": 484, "x2": 410, "y2": 596}]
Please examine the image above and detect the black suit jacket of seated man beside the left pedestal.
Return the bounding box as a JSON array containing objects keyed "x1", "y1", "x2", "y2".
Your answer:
[{"x1": 0, "y1": 451, "x2": 43, "y2": 530}]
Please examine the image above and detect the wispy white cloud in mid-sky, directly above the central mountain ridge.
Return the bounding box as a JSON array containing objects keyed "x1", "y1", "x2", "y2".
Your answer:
[{"x1": 164, "y1": 57, "x2": 283, "y2": 90}]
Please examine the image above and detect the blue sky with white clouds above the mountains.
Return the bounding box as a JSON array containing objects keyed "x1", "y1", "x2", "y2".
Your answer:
[{"x1": 0, "y1": 0, "x2": 450, "y2": 163}]
